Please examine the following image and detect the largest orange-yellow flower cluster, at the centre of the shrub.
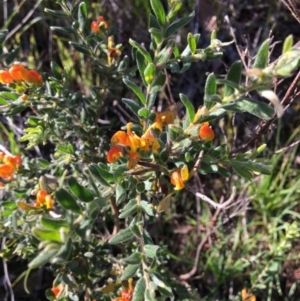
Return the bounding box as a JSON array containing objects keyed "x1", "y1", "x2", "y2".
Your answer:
[{"x1": 107, "y1": 111, "x2": 175, "y2": 169}]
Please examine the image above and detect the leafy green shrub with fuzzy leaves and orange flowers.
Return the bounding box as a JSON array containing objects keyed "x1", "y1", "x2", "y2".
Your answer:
[{"x1": 0, "y1": 0, "x2": 300, "y2": 301}]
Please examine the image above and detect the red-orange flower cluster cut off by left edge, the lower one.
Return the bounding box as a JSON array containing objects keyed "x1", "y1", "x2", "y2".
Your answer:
[{"x1": 0, "y1": 152, "x2": 22, "y2": 187}]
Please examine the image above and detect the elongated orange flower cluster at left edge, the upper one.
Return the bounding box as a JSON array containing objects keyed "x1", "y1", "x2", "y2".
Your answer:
[{"x1": 0, "y1": 63, "x2": 43, "y2": 87}]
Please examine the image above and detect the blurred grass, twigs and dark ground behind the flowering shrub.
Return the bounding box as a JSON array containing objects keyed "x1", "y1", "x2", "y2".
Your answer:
[{"x1": 0, "y1": 0, "x2": 300, "y2": 301}]
